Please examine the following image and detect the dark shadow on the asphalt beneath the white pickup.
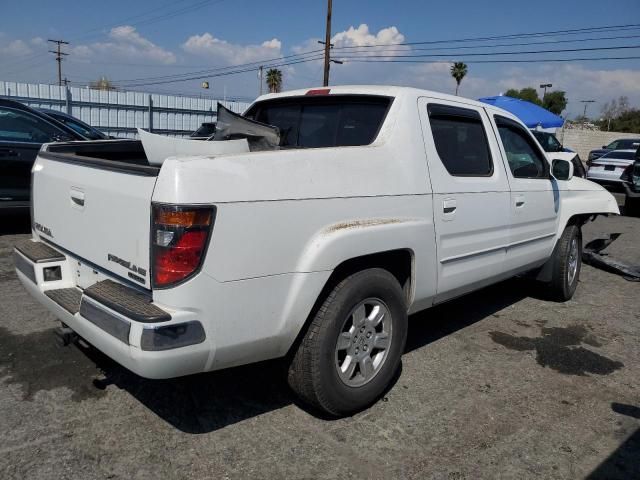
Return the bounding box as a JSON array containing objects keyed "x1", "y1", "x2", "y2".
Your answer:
[{"x1": 83, "y1": 280, "x2": 530, "y2": 434}]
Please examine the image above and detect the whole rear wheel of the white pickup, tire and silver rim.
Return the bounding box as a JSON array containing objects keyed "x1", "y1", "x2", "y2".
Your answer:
[{"x1": 289, "y1": 268, "x2": 407, "y2": 416}]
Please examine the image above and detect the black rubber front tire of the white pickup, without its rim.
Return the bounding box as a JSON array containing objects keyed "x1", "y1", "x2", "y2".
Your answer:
[{"x1": 549, "y1": 225, "x2": 582, "y2": 302}]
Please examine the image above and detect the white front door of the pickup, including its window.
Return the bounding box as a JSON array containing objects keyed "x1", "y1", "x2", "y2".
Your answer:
[{"x1": 493, "y1": 115, "x2": 560, "y2": 273}]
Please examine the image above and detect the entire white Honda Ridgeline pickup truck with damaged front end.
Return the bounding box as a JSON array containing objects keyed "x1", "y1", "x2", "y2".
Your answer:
[{"x1": 14, "y1": 86, "x2": 619, "y2": 415}]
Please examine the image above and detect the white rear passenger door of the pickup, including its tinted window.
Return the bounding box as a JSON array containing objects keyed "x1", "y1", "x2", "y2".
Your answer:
[{"x1": 419, "y1": 98, "x2": 510, "y2": 302}]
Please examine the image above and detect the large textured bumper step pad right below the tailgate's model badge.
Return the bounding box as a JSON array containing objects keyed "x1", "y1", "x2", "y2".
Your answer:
[{"x1": 84, "y1": 280, "x2": 171, "y2": 323}]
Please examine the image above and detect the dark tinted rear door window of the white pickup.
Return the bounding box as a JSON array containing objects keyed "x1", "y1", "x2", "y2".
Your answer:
[{"x1": 427, "y1": 103, "x2": 493, "y2": 177}]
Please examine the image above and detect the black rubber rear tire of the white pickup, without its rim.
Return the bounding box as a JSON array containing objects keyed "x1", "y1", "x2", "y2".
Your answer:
[{"x1": 288, "y1": 268, "x2": 407, "y2": 416}]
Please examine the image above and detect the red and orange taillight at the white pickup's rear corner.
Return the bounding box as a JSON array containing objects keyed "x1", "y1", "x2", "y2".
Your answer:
[{"x1": 151, "y1": 205, "x2": 215, "y2": 288}]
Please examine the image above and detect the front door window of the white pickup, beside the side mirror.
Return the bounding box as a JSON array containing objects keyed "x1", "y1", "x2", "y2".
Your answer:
[{"x1": 494, "y1": 115, "x2": 549, "y2": 179}]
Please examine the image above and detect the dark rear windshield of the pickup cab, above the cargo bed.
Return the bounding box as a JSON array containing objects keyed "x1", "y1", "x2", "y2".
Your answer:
[{"x1": 245, "y1": 95, "x2": 391, "y2": 148}]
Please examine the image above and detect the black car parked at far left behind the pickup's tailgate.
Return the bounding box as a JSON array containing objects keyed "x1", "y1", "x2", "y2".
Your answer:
[{"x1": 0, "y1": 98, "x2": 88, "y2": 210}]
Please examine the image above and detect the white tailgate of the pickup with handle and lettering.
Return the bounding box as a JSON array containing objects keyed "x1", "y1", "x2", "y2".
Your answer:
[{"x1": 32, "y1": 153, "x2": 157, "y2": 288}]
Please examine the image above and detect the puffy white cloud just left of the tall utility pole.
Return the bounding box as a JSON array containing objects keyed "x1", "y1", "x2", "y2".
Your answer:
[{"x1": 182, "y1": 32, "x2": 282, "y2": 64}]
